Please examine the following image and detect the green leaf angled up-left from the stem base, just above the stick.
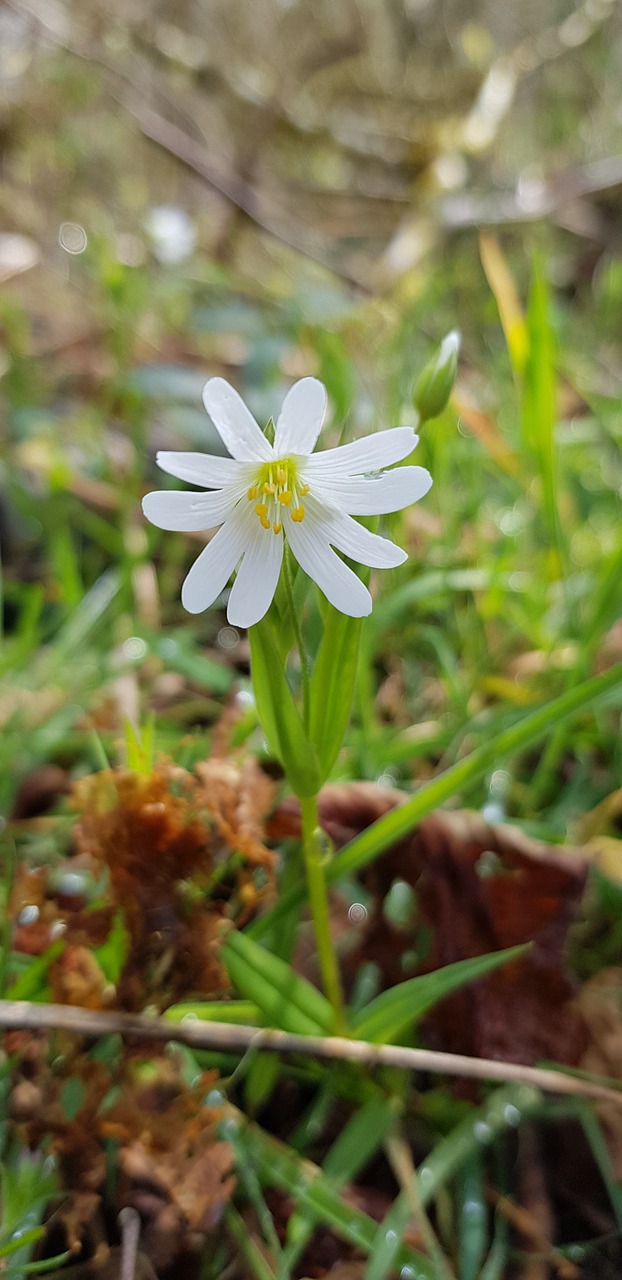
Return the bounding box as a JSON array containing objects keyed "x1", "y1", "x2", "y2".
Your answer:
[{"x1": 220, "y1": 931, "x2": 333, "y2": 1036}]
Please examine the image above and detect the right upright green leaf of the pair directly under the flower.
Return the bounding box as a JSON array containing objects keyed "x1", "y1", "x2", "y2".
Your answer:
[{"x1": 310, "y1": 605, "x2": 362, "y2": 781}]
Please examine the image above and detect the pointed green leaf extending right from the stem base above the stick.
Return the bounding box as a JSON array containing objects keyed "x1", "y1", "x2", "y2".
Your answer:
[{"x1": 351, "y1": 943, "x2": 529, "y2": 1044}]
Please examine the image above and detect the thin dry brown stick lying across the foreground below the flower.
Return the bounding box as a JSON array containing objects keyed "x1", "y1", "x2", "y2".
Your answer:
[{"x1": 0, "y1": 1000, "x2": 622, "y2": 1106}]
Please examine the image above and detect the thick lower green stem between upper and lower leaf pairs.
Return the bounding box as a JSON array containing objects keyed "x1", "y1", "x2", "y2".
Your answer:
[{"x1": 299, "y1": 796, "x2": 346, "y2": 1036}]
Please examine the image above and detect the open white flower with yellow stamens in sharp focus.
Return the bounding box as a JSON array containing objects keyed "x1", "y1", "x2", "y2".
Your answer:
[{"x1": 142, "y1": 378, "x2": 431, "y2": 627}]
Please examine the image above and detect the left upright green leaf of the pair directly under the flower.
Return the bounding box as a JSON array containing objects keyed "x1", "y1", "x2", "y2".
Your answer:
[{"x1": 248, "y1": 617, "x2": 321, "y2": 796}]
